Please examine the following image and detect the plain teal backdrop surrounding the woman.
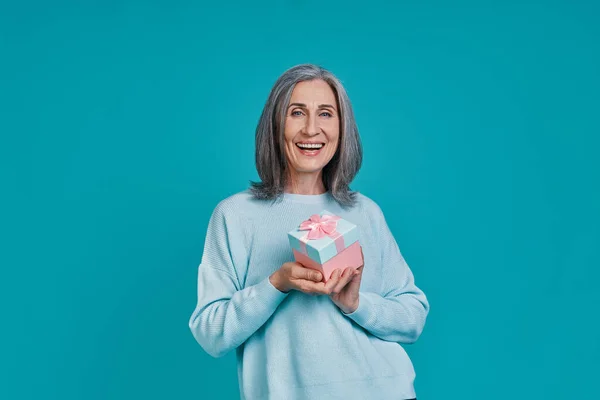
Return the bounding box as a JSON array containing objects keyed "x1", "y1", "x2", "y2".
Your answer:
[{"x1": 0, "y1": 0, "x2": 600, "y2": 399}]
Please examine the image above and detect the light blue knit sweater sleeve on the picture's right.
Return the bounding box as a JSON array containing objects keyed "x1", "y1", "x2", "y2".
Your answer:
[{"x1": 345, "y1": 206, "x2": 429, "y2": 343}]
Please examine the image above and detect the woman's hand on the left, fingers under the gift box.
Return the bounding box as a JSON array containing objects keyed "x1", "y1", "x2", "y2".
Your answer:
[{"x1": 269, "y1": 262, "x2": 331, "y2": 294}]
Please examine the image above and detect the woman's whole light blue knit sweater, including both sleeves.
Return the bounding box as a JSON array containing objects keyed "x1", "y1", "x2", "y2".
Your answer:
[{"x1": 189, "y1": 191, "x2": 429, "y2": 400}]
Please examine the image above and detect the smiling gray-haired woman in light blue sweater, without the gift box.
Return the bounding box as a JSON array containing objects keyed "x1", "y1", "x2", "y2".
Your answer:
[{"x1": 189, "y1": 64, "x2": 429, "y2": 400}]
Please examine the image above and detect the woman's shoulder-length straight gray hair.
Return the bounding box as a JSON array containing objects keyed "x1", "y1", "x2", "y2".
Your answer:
[{"x1": 250, "y1": 64, "x2": 362, "y2": 207}]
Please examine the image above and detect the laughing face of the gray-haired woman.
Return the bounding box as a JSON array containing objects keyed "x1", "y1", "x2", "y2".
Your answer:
[{"x1": 285, "y1": 80, "x2": 340, "y2": 174}]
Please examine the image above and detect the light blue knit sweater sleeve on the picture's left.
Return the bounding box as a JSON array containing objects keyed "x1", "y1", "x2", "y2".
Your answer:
[{"x1": 189, "y1": 203, "x2": 286, "y2": 357}]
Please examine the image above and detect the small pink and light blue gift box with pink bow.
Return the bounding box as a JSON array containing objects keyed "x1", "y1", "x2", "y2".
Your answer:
[{"x1": 288, "y1": 210, "x2": 363, "y2": 281}]
